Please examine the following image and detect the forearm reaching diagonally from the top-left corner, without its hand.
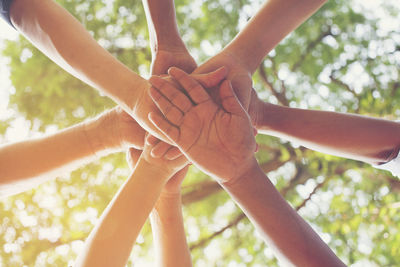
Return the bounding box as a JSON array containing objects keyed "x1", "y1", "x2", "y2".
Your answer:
[{"x1": 10, "y1": 0, "x2": 146, "y2": 110}]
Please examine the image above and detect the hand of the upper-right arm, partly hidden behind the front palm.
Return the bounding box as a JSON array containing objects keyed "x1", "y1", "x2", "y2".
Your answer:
[{"x1": 193, "y1": 51, "x2": 252, "y2": 111}]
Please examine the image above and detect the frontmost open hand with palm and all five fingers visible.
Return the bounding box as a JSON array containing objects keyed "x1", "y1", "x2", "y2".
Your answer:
[{"x1": 149, "y1": 68, "x2": 256, "y2": 183}]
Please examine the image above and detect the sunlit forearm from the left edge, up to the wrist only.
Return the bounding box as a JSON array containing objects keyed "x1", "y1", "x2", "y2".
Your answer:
[{"x1": 0, "y1": 113, "x2": 107, "y2": 195}]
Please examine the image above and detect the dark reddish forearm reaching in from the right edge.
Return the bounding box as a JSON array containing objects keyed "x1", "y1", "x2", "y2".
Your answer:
[{"x1": 257, "y1": 103, "x2": 400, "y2": 164}]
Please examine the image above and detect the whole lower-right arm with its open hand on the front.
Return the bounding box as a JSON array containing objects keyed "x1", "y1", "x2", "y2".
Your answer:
[{"x1": 149, "y1": 68, "x2": 345, "y2": 266}]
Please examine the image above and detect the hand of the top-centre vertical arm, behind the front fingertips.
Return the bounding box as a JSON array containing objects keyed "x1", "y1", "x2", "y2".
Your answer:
[{"x1": 151, "y1": 48, "x2": 197, "y2": 75}]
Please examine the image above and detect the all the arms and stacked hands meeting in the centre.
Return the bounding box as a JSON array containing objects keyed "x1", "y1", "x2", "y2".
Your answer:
[{"x1": 8, "y1": 0, "x2": 400, "y2": 267}]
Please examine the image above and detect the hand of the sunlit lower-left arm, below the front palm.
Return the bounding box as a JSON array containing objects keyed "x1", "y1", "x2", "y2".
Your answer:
[{"x1": 127, "y1": 135, "x2": 188, "y2": 179}]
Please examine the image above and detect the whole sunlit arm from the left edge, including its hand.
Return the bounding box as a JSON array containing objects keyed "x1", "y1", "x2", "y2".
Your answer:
[{"x1": 0, "y1": 107, "x2": 145, "y2": 199}]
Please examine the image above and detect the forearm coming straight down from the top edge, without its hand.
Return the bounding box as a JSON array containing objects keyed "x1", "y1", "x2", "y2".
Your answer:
[{"x1": 142, "y1": 0, "x2": 185, "y2": 53}]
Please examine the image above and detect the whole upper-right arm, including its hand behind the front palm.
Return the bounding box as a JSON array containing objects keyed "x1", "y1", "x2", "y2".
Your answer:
[{"x1": 194, "y1": 0, "x2": 326, "y2": 112}]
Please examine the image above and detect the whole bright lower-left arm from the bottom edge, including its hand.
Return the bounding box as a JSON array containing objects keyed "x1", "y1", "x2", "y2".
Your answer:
[{"x1": 75, "y1": 138, "x2": 187, "y2": 267}]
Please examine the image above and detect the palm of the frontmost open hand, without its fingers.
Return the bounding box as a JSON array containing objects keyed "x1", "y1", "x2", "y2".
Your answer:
[{"x1": 177, "y1": 101, "x2": 255, "y2": 182}]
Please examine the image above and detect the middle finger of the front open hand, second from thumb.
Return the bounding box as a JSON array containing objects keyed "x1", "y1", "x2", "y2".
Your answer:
[{"x1": 149, "y1": 76, "x2": 193, "y2": 112}]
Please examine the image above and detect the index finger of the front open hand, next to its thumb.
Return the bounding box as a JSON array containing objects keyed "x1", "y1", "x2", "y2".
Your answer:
[{"x1": 168, "y1": 67, "x2": 211, "y2": 104}]
